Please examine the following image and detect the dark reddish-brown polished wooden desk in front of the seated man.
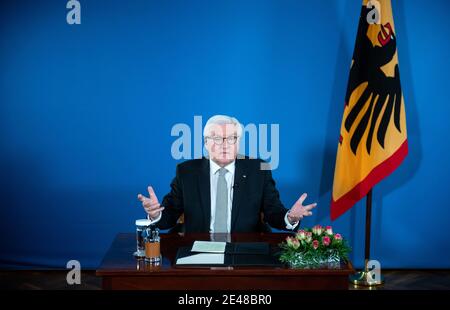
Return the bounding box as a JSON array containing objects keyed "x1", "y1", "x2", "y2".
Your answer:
[{"x1": 96, "y1": 233, "x2": 354, "y2": 290}]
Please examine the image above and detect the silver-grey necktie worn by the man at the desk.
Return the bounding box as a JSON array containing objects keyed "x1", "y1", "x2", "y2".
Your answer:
[{"x1": 214, "y1": 168, "x2": 228, "y2": 233}]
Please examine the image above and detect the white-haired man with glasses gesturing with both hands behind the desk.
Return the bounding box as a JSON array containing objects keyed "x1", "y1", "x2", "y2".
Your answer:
[{"x1": 138, "y1": 115, "x2": 317, "y2": 233}]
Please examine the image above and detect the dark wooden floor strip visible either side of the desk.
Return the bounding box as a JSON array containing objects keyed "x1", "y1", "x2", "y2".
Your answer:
[{"x1": 0, "y1": 270, "x2": 450, "y2": 290}]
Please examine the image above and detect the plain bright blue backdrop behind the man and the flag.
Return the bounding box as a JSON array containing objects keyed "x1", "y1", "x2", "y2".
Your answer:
[{"x1": 0, "y1": 0, "x2": 450, "y2": 268}]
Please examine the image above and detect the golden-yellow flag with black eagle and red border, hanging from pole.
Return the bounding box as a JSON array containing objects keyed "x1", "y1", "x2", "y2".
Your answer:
[{"x1": 331, "y1": 0, "x2": 408, "y2": 220}]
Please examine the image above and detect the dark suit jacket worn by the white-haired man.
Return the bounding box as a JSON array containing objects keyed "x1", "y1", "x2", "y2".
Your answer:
[{"x1": 157, "y1": 157, "x2": 288, "y2": 232}]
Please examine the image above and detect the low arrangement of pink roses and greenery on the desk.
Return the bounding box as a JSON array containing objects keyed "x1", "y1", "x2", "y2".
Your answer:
[{"x1": 280, "y1": 225, "x2": 350, "y2": 268}]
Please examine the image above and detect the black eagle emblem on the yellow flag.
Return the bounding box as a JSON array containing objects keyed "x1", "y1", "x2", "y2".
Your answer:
[{"x1": 340, "y1": 6, "x2": 402, "y2": 155}]
